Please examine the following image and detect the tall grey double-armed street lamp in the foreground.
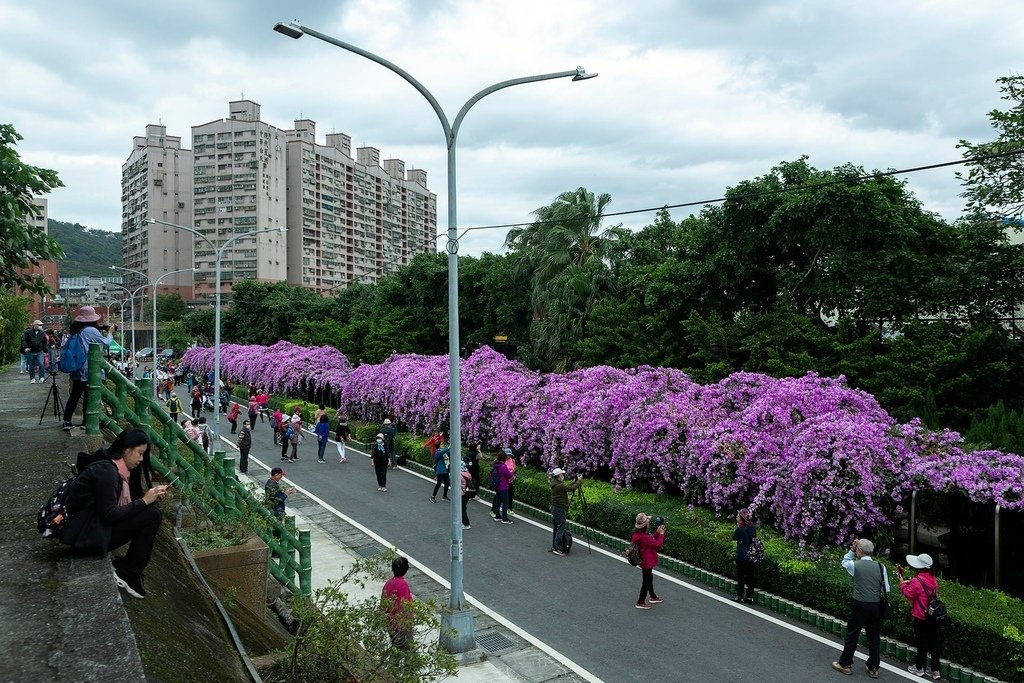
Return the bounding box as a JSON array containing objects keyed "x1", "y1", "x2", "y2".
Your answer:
[{"x1": 273, "y1": 22, "x2": 597, "y2": 652}]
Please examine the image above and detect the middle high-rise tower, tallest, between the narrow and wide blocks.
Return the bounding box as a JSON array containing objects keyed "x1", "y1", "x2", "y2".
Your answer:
[{"x1": 193, "y1": 99, "x2": 290, "y2": 300}]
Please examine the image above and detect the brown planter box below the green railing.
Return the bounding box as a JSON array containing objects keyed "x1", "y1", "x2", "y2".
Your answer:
[{"x1": 193, "y1": 535, "x2": 270, "y2": 614}]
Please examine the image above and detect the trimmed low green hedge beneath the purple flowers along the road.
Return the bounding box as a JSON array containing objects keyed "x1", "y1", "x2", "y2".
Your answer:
[{"x1": 249, "y1": 398, "x2": 1024, "y2": 682}]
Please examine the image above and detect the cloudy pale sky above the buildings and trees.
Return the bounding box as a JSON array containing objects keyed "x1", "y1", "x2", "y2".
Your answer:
[{"x1": 0, "y1": 0, "x2": 1024, "y2": 254}]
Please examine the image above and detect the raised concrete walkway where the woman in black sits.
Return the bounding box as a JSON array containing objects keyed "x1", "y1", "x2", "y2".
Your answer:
[{"x1": 0, "y1": 366, "x2": 145, "y2": 683}]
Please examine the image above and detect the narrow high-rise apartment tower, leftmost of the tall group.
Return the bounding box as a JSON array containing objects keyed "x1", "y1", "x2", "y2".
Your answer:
[{"x1": 121, "y1": 124, "x2": 193, "y2": 299}]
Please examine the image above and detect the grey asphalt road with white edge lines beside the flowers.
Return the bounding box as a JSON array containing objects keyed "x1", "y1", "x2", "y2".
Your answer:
[{"x1": 176, "y1": 389, "x2": 910, "y2": 683}]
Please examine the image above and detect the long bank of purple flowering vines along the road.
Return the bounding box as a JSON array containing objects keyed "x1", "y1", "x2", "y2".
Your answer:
[{"x1": 182, "y1": 342, "x2": 1024, "y2": 545}]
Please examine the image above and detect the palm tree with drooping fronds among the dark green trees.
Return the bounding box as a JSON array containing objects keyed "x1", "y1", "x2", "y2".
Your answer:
[{"x1": 505, "y1": 187, "x2": 626, "y2": 369}]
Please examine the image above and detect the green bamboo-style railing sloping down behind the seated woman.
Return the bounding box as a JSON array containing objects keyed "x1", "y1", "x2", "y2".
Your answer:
[{"x1": 85, "y1": 344, "x2": 312, "y2": 595}]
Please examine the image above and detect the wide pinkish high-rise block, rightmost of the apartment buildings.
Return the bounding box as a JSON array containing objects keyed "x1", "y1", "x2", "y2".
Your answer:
[{"x1": 287, "y1": 119, "x2": 437, "y2": 293}]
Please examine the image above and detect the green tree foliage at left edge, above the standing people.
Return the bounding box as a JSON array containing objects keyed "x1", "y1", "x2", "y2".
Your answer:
[{"x1": 0, "y1": 124, "x2": 63, "y2": 294}]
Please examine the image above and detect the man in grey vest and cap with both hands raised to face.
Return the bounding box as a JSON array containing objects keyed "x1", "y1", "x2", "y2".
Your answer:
[{"x1": 833, "y1": 539, "x2": 889, "y2": 678}]
